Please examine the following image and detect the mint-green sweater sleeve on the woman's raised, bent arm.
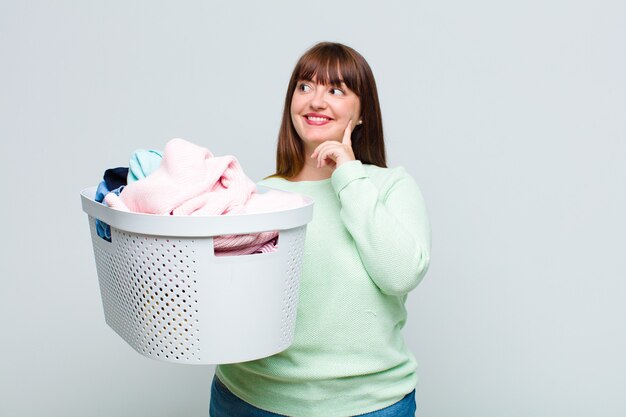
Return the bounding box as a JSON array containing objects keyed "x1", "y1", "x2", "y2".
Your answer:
[{"x1": 331, "y1": 160, "x2": 431, "y2": 295}]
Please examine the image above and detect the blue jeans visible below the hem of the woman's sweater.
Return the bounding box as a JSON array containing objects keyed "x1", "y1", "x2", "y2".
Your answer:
[{"x1": 209, "y1": 376, "x2": 415, "y2": 417}]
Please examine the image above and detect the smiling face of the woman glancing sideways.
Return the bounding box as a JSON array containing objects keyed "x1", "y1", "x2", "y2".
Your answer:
[{"x1": 291, "y1": 76, "x2": 361, "y2": 150}]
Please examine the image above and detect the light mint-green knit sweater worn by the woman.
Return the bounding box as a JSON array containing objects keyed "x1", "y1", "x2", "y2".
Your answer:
[{"x1": 216, "y1": 161, "x2": 430, "y2": 417}]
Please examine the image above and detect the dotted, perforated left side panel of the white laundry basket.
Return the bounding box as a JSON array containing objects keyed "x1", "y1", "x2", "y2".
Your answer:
[{"x1": 89, "y1": 216, "x2": 200, "y2": 362}]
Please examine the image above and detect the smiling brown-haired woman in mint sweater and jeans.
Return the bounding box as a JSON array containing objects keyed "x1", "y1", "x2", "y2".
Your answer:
[{"x1": 210, "y1": 42, "x2": 430, "y2": 417}]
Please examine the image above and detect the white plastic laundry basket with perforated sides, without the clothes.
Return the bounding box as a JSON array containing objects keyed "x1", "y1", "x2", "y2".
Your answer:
[{"x1": 81, "y1": 187, "x2": 313, "y2": 364}]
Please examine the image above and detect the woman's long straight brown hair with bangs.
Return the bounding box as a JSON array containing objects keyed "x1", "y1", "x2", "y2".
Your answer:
[{"x1": 268, "y1": 42, "x2": 387, "y2": 178}]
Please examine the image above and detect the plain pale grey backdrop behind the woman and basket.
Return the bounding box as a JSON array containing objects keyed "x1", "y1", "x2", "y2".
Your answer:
[{"x1": 0, "y1": 0, "x2": 626, "y2": 417}]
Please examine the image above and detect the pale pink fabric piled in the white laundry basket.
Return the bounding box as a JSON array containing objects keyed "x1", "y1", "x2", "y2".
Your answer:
[{"x1": 104, "y1": 139, "x2": 304, "y2": 255}]
